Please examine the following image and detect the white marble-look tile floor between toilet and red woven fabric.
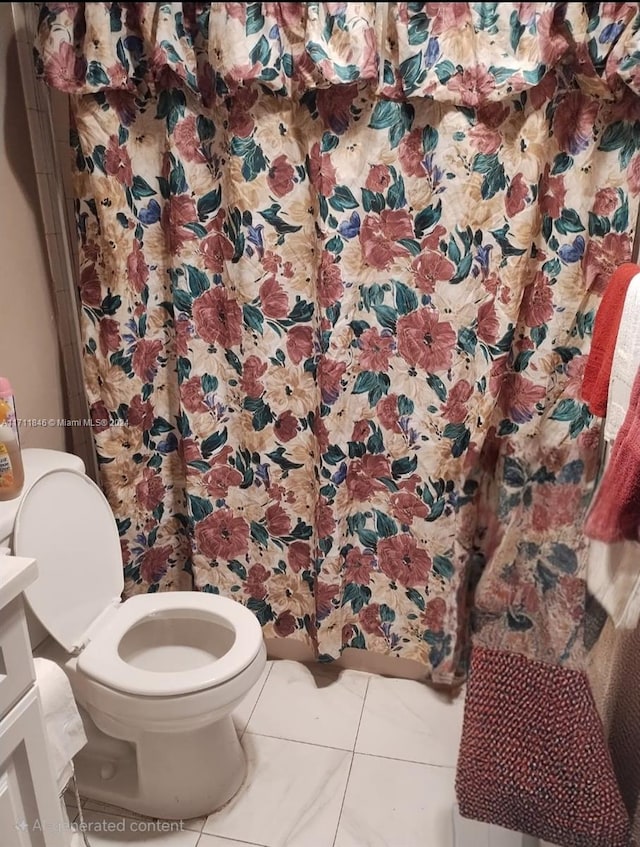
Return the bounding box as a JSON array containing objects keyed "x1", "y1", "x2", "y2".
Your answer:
[{"x1": 67, "y1": 661, "x2": 470, "y2": 847}]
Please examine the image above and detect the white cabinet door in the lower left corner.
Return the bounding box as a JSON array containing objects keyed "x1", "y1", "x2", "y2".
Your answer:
[{"x1": 0, "y1": 688, "x2": 71, "y2": 847}]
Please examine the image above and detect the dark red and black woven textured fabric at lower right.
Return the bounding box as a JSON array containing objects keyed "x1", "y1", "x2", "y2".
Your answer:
[{"x1": 456, "y1": 648, "x2": 629, "y2": 847}]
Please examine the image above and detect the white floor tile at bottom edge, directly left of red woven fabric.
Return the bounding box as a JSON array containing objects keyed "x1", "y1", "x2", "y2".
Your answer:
[{"x1": 332, "y1": 753, "x2": 455, "y2": 847}]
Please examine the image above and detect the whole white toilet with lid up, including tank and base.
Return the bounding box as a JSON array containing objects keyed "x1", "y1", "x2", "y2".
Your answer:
[{"x1": 0, "y1": 450, "x2": 266, "y2": 819}]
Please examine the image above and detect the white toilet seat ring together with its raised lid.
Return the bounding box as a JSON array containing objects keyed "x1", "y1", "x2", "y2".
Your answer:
[{"x1": 14, "y1": 469, "x2": 262, "y2": 697}]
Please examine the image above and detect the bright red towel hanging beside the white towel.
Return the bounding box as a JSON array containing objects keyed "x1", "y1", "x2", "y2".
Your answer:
[{"x1": 582, "y1": 262, "x2": 640, "y2": 418}]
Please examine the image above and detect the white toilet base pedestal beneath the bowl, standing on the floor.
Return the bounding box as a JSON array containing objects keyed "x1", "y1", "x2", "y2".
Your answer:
[{"x1": 75, "y1": 710, "x2": 247, "y2": 820}]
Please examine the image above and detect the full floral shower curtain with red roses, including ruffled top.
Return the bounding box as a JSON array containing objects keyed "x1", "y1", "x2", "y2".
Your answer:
[{"x1": 36, "y1": 3, "x2": 640, "y2": 844}]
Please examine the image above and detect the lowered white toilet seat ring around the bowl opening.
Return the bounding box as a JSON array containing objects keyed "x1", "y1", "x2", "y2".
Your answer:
[{"x1": 78, "y1": 591, "x2": 262, "y2": 697}]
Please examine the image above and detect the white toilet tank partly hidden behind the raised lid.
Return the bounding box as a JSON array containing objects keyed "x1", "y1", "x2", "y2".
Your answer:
[{"x1": 0, "y1": 447, "x2": 85, "y2": 649}]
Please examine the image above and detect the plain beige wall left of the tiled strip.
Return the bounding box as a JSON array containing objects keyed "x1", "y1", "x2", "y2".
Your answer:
[{"x1": 0, "y1": 3, "x2": 67, "y2": 450}]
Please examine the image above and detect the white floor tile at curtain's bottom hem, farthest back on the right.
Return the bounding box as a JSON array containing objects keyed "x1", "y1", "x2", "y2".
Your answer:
[{"x1": 355, "y1": 676, "x2": 464, "y2": 767}]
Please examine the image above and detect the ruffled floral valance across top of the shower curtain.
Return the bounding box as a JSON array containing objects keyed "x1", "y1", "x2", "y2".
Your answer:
[{"x1": 36, "y1": 2, "x2": 640, "y2": 107}]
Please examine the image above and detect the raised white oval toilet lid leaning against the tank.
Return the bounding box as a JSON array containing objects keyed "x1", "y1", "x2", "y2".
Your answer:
[{"x1": 13, "y1": 469, "x2": 124, "y2": 652}]
